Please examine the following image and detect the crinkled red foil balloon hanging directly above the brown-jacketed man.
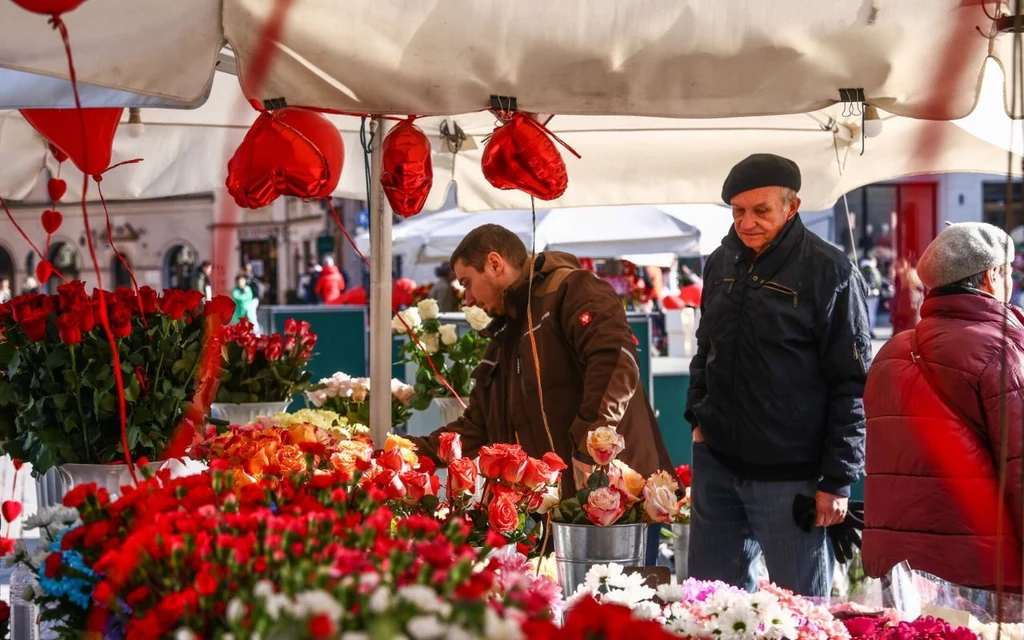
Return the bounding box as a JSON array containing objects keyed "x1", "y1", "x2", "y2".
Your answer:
[{"x1": 481, "y1": 112, "x2": 569, "y2": 200}]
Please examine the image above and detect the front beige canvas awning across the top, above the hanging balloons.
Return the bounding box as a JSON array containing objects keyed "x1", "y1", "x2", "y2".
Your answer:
[{"x1": 0, "y1": 0, "x2": 1012, "y2": 119}]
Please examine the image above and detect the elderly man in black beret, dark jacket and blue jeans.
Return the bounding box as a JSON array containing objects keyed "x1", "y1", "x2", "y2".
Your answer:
[{"x1": 686, "y1": 154, "x2": 870, "y2": 596}]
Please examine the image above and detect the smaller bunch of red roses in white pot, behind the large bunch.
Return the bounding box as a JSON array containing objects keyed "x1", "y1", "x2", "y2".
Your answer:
[{"x1": 217, "y1": 318, "x2": 316, "y2": 404}]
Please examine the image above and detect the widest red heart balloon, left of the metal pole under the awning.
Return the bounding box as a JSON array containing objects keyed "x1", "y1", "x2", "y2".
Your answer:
[{"x1": 227, "y1": 106, "x2": 345, "y2": 209}]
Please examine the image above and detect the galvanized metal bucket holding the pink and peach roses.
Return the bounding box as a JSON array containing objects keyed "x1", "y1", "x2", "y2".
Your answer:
[{"x1": 551, "y1": 522, "x2": 647, "y2": 598}]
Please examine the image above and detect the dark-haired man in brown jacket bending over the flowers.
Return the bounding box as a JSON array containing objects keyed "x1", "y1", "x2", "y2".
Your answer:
[{"x1": 411, "y1": 224, "x2": 672, "y2": 493}]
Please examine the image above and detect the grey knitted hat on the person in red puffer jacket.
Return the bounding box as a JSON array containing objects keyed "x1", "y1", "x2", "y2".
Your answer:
[{"x1": 918, "y1": 222, "x2": 1014, "y2": 289}]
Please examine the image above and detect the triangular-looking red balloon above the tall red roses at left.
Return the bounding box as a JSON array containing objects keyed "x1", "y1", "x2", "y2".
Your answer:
[{"x1": 22, "y1": 106, "x2": 124, "y2": 175}]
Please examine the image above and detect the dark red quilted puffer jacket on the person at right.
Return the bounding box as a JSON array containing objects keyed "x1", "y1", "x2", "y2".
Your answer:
[{"x1": 863, "y1": 289, "x2": 1024, "y2": 589}]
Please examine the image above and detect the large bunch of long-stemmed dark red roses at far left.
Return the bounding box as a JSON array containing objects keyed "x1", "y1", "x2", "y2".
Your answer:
[{"x1": 0, "y1": 281, "x2": 234, "y2": 473}]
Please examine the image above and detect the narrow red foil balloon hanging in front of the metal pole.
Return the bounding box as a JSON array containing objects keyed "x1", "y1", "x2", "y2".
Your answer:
[{"x1": 381, "y1": 120, "x2": 434, "y2": 218}]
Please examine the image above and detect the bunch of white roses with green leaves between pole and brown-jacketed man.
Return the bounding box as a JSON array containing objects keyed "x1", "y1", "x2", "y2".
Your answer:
[{"x1": 391, "y1": 298, "x2": 490, "y2": 411}]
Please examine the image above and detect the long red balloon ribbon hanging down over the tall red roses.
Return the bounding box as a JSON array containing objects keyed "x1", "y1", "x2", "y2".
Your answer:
[{"x1": 50, "y1": 15, "x2": 138, "y2": 485}]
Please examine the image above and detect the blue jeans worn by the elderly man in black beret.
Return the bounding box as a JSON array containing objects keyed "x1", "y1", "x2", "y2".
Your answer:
[{"x1": 689, "y1": 442, "x2": 836, "y2": 597}]
